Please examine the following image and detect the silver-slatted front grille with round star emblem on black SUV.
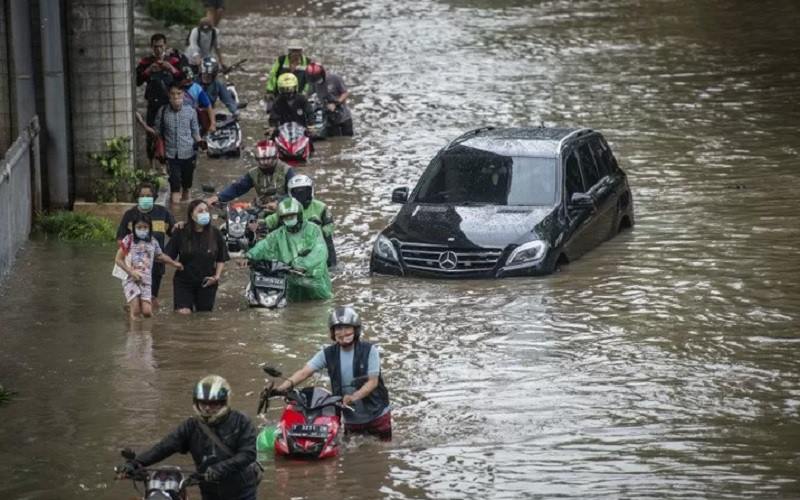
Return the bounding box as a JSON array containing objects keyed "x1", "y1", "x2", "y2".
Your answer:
[{"x1": 398, "y1": 241, "x2": 503, "y2": 274}]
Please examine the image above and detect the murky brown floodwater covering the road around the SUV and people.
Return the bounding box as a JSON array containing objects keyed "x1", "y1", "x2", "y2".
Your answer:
[{"x1": 0, "y1": 0, "x2": 800, "y2": 499}]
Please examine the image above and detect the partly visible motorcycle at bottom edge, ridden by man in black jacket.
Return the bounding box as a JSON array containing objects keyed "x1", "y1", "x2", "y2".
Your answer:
[{"x1": 114, "y1": 449, "x2": 203, "y2": 500}]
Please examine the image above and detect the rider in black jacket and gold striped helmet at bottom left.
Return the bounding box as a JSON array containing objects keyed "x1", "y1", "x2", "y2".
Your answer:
[{"x1": 119, "y1": 375, "x2": 262, "y2": 500}]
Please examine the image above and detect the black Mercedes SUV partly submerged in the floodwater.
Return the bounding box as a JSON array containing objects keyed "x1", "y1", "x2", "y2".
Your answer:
[{"x1": 370, "y1": 127, "x2": 633, "y2": 278}]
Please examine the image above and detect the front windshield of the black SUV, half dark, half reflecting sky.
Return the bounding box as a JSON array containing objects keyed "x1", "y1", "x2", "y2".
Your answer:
[{"x1": 415, "y1": 146, "x2": 556, "y2": 206}]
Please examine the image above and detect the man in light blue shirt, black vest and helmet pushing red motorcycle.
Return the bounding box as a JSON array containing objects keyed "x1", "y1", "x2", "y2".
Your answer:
[{"x1": 273, "y1": 307, "x2": 392, "y2": 441}]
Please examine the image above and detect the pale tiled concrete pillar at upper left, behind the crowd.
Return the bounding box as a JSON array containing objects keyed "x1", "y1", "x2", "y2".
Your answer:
[{"x1": 66, "y1": 0, "x2": 134, "y2": 198}]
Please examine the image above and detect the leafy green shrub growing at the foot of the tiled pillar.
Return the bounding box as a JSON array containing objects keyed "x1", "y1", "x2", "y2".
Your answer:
[{"x1": 89, "y1": 137, "x2": 160, "y2": 203}]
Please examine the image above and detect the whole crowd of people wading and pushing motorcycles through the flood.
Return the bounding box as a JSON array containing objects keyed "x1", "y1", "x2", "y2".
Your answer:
[{"x1": 114, "y1": 5, "x2": 384, "y2": 500}]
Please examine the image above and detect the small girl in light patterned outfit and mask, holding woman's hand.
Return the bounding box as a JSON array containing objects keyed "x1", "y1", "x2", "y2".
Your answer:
[{"x1": 114, "y1": 213, "x2": 183, "y2": 319}]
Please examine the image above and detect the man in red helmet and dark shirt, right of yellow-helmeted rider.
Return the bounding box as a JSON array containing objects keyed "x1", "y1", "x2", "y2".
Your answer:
[{"x1": 306, "y1": 63, "x2": 353, "y2": 137}]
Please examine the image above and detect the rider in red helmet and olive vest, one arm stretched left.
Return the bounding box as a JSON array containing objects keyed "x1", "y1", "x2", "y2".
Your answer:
[{"x1": 206, "y1": 140, "x2": 295, "y2": 212}]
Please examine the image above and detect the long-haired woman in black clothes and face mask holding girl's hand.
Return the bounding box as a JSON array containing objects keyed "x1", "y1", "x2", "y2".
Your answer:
[{"x1": 166, "y1": 200, "x2": 230, "y2": 314}]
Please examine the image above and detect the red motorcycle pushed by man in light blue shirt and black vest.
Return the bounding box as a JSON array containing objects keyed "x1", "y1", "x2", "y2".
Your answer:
[{"x1": 257, "y1": 365, "x2": 352, "y2": 459}]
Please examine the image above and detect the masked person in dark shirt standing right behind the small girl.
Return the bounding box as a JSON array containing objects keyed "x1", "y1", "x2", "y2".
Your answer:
[{"x1": 117, "y1": 182, "x2": 175, "y2": 309}]
